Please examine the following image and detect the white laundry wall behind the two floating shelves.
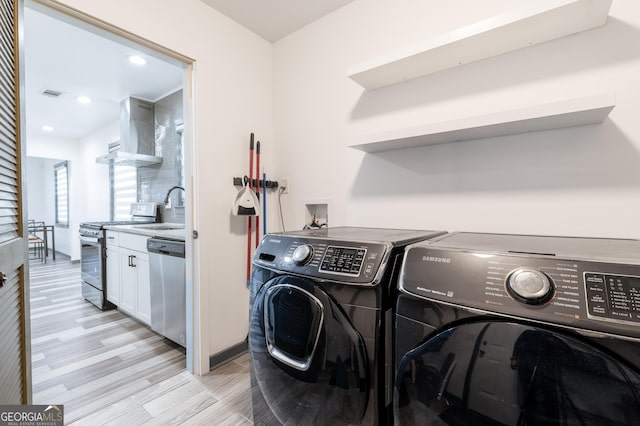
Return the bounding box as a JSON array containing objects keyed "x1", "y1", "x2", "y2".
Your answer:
[{"x1": 274, "y1": 0, "x2": 640, "y2": 238}]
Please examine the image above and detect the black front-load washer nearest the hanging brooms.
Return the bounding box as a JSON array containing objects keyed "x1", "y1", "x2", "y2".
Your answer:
[{"x1": 249, "y1": 227, "x2": 443, "y2": 425}]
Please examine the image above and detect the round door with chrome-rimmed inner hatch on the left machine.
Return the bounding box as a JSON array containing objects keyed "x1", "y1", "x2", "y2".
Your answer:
[{"x1": 249, "y1": 276, "x2": 370, "y2": 424}]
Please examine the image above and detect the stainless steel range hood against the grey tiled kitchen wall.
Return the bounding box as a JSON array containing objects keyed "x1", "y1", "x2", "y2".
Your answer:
[{"x1": 96, "y1": 98, "x2": 162, "y2": 167}]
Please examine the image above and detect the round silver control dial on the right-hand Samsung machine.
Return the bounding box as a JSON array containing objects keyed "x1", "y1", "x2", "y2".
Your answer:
[{"x1": 506, "y1": 268, "x2": 554, "y2": 305}]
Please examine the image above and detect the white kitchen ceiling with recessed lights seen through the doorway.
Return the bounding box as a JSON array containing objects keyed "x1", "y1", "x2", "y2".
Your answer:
[{"x1": 24, "y1": 8, "x2": 184, "y2": 139}]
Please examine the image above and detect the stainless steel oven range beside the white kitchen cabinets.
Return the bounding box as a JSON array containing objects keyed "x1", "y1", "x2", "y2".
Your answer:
[{"x1": 80, "y1": 203, "x2": 158, "y2": 310}]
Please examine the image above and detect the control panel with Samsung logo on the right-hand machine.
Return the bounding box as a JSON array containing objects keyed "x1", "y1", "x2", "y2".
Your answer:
[{"x1": 399, "y1": 245, "x2": 640, "y2": 338}]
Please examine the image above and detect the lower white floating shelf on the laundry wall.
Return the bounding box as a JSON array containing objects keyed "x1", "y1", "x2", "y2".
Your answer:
[{"x1": 349, "y1": 93, "x2": 616, "y2": 152}]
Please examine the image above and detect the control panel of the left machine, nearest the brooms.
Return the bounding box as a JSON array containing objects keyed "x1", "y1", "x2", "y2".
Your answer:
[{"x1": 253, "y1": 235, "x2": 392, "y2": 285}]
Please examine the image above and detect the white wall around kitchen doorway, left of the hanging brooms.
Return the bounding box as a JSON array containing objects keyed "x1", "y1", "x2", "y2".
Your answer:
[{"x1": 47, "y1": 0, "x2": 273, "y2": 364}]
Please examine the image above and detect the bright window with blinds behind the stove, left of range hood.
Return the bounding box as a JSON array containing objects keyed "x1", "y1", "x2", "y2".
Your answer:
[{"x1": 109, "y1": 164, "x2": 138, "y2": 220}]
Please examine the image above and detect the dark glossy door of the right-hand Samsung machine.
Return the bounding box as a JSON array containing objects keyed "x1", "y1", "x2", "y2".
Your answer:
[{"x1": 394, "y1": 318, "x2": 640, "y2": 425}]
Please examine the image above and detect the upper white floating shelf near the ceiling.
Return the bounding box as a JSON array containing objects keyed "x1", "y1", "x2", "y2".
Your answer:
[{"x1": 347, "y1": 0, "x2": 613, "y2": 89}]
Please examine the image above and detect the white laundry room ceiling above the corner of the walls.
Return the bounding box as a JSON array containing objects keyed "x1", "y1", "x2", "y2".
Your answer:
[{"x1": 202, "y1": 0, "x2": 353, "y2": 43}]
